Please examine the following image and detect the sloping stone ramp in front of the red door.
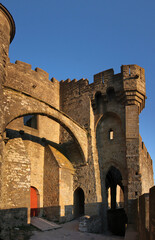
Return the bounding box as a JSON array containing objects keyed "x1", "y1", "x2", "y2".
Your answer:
[{"x1": 31, "y1": 217, "x2": 61, "y2": 231}]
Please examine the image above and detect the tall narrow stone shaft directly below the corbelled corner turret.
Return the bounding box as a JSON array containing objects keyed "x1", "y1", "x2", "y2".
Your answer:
[{"x1": 126, "y1": 105, "x2": 142, "y2": 199}]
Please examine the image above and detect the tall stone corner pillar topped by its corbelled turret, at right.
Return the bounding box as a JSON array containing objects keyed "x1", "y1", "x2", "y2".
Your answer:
[{"x1": 121, "y1": 65, "x2": 146, "y2": 204}]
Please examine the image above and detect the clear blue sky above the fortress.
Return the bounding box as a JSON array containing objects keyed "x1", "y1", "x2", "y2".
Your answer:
[{"x1": 1, "y1": 0, "x2": 155, "y2": 180}]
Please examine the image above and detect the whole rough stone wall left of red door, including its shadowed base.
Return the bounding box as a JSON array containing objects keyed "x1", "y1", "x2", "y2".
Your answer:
[{"x1": 0, "y1": 138, "x2": 31, "y2": 234}]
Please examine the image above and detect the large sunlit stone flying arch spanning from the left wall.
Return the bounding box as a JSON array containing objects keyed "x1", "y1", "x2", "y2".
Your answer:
[{"x1": 3, "y1": 89, "x2": 88, "y2": 164}]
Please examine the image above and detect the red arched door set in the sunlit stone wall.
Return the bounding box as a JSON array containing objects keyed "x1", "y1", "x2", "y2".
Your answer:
[{"x1": 30, "y1": 187, "x2": 39, "y2": 217}]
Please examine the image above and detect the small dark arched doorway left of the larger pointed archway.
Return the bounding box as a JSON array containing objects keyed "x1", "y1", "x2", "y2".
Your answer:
[{"x1": 74, "y1": 188, "x2": 85, "y2": 218}]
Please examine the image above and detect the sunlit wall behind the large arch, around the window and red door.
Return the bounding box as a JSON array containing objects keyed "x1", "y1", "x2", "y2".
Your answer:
[{"x1": 7, "y1": 115, "x2": 59, "y2": 208}]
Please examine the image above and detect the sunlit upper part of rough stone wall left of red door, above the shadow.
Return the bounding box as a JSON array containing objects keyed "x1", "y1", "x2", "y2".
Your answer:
[{"x1": 2, "y1": 138, "x2": 31, "y2": 209}]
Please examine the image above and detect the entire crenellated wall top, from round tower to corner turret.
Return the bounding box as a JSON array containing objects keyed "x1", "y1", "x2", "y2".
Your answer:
[{"x1": 4, "y1": 60, "x2": 145, "y2": 112}]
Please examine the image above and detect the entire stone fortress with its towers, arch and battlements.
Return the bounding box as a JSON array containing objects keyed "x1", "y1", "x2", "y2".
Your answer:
[{"x1": 0, "y1": 4, "x2": 154, "y2": 239}]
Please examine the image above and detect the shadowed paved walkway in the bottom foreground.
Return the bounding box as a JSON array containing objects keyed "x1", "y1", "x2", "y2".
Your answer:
[{"x1": 30, "y1": 220, "x2": 124, "y2": 240}]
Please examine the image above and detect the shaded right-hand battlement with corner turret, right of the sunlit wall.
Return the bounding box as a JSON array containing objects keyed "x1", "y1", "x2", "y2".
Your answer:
[{"x1": 60, "y1": 65, "x2": 146, "y2": 113}]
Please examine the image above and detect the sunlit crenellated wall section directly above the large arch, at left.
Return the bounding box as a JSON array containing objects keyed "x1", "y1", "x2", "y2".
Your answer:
[{"x1": 3, "y1": 61, "x2": 60, "y2": 109}]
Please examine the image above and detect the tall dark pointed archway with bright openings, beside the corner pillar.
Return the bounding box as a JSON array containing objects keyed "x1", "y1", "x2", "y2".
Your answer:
[{"x1": 105, "y1": 166, "x2": 127, "y2": 236}]
